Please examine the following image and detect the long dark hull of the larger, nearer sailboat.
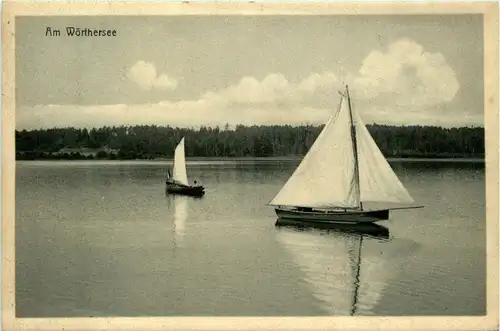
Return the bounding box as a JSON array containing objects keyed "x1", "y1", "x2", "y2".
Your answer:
[{"x1": 275, "y1": 208, "x2": 389, "y2": 224}]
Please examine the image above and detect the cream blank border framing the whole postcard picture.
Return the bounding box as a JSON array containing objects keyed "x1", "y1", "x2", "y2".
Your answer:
[{"x1": 2, "y1": 1, "x2": 499, "y2": 331}]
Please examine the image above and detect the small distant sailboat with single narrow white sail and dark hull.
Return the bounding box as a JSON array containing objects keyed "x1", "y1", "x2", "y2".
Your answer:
[{"x1": 166, "y1": 137, "x2": 205, "y2": 197}]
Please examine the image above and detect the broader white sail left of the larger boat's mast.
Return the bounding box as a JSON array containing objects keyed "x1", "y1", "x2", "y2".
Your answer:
[{"x1": 270, "y1": 97, "x2": 359, "y2": 208}]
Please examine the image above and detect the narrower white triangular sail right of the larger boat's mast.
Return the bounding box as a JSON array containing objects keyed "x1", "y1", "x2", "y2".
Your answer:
[{"x1": 352, "y1": 107, "x2": 414, "y2": 204}]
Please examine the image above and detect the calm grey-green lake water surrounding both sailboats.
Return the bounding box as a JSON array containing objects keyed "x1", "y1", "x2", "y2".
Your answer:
[{"x1": 16, "y1": 162, "x2": 486, "y2": 317}]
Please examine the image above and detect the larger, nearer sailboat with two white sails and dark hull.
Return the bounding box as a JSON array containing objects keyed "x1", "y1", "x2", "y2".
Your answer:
[{"x1": 269, "y1": 85, "x2": 423, "y2": 223}]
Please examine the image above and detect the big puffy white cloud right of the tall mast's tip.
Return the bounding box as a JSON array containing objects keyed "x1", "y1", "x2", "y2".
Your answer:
[{"x1": 354, "y1": 39, "x2": 459, "y2": 107}]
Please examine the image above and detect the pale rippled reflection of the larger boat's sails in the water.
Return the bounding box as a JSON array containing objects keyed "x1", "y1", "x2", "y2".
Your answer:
[{"x1": 276, "y1": 224, "x2": 393, "y2": 316}]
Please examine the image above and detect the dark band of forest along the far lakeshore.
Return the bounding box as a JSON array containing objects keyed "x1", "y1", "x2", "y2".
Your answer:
[{"x1": 15, "y1": 124, "x2": 485, "y2": 160}]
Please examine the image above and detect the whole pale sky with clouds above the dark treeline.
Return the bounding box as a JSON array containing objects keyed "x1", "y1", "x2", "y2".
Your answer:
[{"x1": 16, "y1": 15, "x2": 484, "y2": 129}]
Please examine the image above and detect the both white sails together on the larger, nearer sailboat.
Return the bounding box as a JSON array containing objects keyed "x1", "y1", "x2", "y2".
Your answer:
[{"x1": 270, "y1": 87, "x2": 413, "y2": 208}]
